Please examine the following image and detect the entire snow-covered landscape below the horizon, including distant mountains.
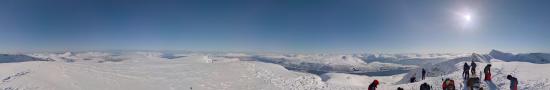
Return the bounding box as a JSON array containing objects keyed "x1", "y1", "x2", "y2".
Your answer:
[{"x1": 0, "y1": 50, "x2": 550, "y2": 90}]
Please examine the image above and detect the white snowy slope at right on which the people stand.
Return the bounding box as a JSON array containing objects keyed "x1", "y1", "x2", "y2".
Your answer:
[{"x1": 322, "y1": 55, "x2": 550, "y2": 90}]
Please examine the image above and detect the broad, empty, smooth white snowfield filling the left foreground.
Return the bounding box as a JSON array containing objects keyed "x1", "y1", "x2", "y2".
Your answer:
[{"x1": 0, "y1": 53, "x2": 323, "y2": 90}]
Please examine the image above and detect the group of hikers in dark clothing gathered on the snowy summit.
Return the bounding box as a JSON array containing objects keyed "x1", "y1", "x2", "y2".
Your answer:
[{"x1": 368, "y1": 60, "x2": 518, "y2": 90}]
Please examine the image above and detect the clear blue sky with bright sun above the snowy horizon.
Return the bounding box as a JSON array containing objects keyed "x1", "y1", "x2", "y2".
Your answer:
[{"x1": 0, "y1": 0, "x2": 550, "y2": 53}]
